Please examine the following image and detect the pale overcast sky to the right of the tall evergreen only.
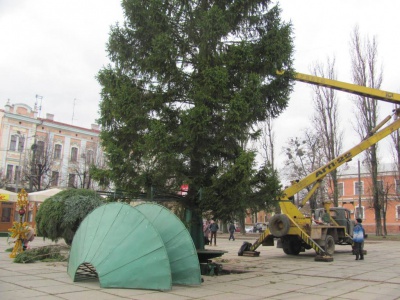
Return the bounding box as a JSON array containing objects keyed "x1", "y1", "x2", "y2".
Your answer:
[{"x1": 275, "y1": 0, "x2": 400, "y2": 172}]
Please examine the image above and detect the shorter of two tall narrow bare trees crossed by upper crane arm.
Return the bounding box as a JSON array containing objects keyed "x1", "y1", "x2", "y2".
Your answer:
[{"x1": 312, "y1": 58, "x2": 343, "y2": 206}]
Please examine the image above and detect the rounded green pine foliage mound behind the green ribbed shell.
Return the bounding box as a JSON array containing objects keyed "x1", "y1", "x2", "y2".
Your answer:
[{"x1": 36, "y1": 189, "x2": 104, "y2": 245}]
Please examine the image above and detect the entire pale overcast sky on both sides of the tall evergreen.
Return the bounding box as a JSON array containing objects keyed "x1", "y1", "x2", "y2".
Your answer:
[{"x1": 0, "y1": 0, "x2": 400, "y2": 176}]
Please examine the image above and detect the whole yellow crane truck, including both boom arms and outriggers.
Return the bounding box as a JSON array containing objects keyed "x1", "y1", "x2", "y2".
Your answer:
[{"x1": 238, "y1": 72, "x2": 400, "y2": 261}]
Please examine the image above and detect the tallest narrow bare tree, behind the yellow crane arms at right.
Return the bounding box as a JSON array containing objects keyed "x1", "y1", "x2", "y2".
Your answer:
[{"x1": 350, "y1": 27, "x2": 382, "y2": 235}]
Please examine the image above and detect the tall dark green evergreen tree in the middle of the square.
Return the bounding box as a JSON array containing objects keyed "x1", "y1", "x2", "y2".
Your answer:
[{"x1": 98, "y1": 0, "x2": 293, "y2": 246}]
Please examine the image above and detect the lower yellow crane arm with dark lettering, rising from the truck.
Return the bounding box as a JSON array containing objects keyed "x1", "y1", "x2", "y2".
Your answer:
[{"x1": 283, "y1": 110, "x2": 400, "y2": 199}]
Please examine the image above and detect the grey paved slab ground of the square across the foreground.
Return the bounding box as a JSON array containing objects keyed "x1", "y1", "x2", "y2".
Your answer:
[{"x1": 0, "y1": 234, "x2": 400, "y2": 300}]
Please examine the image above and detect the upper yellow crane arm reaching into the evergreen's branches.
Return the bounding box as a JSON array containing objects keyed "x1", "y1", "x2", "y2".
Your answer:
[{"x1": 294, "y1": 72, "x2": 400, "y2": 104}]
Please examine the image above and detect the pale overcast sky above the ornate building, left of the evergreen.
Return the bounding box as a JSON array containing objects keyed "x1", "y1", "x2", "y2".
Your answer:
[{"x1": 0, "y1": 0, "x2": 123, "y2": 127}]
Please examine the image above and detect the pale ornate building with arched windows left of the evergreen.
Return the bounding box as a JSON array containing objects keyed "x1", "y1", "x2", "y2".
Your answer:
[{"x1": 0, "y1": 102, "x2": 104, "y2": 192}]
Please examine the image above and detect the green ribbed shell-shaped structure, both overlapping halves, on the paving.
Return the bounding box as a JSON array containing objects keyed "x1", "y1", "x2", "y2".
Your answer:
[{"x1": 68, "y1": 203, "x2": 201, "y2": 290}]
